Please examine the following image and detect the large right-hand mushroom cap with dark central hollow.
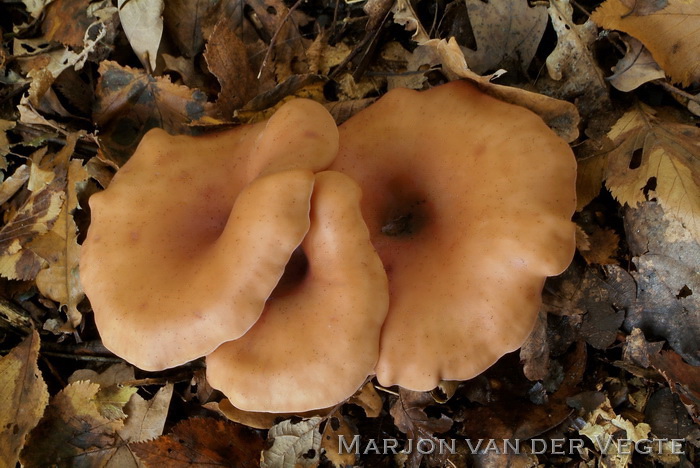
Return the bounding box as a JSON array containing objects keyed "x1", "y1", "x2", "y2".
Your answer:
[{"x1": 331, "y1": 82, "x2": 576, "y2": 390}]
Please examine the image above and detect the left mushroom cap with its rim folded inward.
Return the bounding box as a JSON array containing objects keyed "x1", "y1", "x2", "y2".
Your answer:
[{"x1": 80, "y1": 100, "x2": 338, "y2": 370}]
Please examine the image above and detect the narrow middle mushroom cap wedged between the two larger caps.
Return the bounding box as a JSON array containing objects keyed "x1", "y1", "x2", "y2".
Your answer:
[{"x1": 207, "y1": 172, "x2": 389, "y2": 413}]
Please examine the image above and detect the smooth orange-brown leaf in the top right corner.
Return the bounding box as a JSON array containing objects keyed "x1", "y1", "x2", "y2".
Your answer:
[{"x1": 591, "y1": 0, "x2": 700, "y2": 86}]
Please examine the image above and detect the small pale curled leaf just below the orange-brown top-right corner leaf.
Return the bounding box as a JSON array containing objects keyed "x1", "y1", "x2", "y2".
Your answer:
[{"x1": 608, "y1": 37, "x2": 666, "y2": 92}]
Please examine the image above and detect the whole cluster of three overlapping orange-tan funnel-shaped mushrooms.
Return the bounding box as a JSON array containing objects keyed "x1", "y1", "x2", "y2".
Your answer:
[{"x1": 80, "y1": 82, "x2": 576, "y2": 412}]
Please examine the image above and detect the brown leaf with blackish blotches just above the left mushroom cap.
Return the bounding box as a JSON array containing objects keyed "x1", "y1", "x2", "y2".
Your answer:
[{"x1": 94, "y1": 61, "x2": 217, "y2": 166}]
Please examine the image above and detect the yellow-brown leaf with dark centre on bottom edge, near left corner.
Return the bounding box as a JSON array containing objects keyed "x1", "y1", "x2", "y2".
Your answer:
[{"x1": 20, "y1": 381, "x2": 123, "y2": 466}]
